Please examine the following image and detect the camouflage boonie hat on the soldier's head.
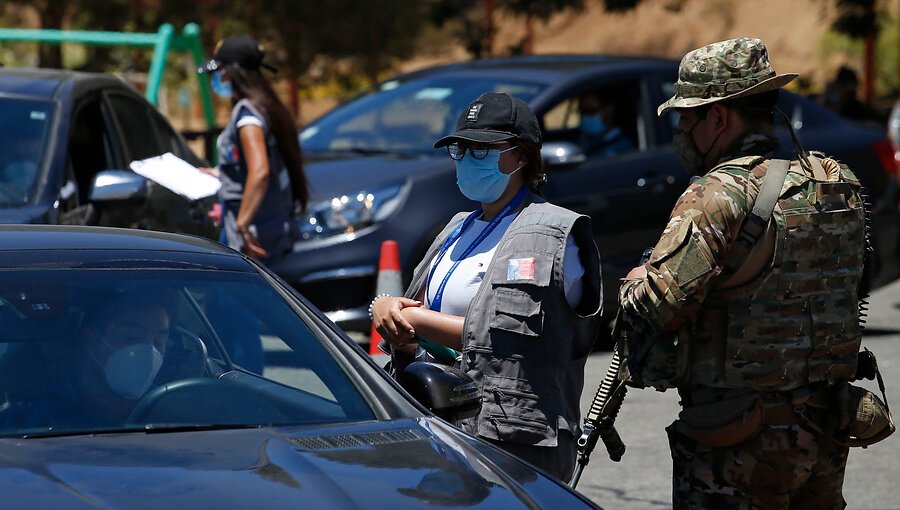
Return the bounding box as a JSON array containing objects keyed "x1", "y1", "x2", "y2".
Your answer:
[{"x1": 656, "y1": 37, "x2": 798, "y2": 116}]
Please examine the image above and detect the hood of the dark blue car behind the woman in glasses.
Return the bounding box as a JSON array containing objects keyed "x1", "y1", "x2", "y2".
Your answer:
[{"x1": 303, "y1": 155, "x2": 450, "y2": 202}]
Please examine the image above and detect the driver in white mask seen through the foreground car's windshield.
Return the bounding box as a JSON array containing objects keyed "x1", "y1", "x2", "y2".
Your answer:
[{"x1": 0, "y1": 289, "x2": 173, "y2": 428}]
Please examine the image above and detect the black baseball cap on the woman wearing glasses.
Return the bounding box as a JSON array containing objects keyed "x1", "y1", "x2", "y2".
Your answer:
[{"x1": 434, "y1": 92, "x2": 541, "y2": 148}]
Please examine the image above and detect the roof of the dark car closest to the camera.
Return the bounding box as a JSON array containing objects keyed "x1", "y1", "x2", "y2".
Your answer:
[{"x1": 0, "y1": 225, "x2": 255, "y2": 271}]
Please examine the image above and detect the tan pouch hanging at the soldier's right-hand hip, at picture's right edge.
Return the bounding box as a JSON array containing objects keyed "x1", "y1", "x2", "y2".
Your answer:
[{"x1": 835, "y1": 383, "x2": 897, "y2": 448}]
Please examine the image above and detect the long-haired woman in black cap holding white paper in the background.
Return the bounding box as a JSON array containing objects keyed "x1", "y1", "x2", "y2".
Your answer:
[{"x1": 198, "y1": 35, "x2": 308, "y2": 265}]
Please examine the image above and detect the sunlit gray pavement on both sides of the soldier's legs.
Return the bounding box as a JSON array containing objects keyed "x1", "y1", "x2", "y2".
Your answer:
[{"x1": 578, "y1": 282, "x2": 900, "y2": 510}]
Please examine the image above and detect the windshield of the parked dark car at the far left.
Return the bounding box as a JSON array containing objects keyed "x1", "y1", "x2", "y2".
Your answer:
[{"x1": 0, "y1": 98, "x2": 53, "y2": 206}]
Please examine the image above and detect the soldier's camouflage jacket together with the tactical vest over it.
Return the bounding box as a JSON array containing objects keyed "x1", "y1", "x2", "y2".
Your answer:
[{"x1": 619, "y1": 135, "x2": 865, "y2": 391}]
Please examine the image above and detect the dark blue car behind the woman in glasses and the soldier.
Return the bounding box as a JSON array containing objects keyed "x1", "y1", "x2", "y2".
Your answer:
[{"x1": 274, "y1": 55, "x2": 900, "y2": 331}]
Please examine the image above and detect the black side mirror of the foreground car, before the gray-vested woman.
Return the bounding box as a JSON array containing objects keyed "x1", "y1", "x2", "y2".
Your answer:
[{"x1": 400, "y1": 361, "x2": 481, "y2": 422}]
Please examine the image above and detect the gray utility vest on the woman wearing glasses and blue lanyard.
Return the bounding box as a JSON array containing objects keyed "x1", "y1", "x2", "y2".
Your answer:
[{"x1": 406, "y1": 196, "x2": 603, "y2": 446}]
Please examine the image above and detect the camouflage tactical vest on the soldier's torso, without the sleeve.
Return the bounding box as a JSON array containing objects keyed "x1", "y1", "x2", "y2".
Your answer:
[{"x1": 685, "y1": 155, "x2": 865, "y2": 391}]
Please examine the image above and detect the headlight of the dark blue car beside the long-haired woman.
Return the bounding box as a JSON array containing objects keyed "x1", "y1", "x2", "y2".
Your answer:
[{"x1": 297, "y1": 183, "x2": 409, "y2": 240}]
